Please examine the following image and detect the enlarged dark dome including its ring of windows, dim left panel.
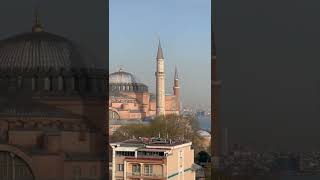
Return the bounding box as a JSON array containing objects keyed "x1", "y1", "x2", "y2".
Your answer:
[{"x1": 0, "y1": 27, "x2": 107, "y2": 97}]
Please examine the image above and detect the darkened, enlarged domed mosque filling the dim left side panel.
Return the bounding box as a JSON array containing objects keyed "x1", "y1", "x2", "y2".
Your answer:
[{"x1": 0, "y1": 12, "x2": 108, "y2": 180}]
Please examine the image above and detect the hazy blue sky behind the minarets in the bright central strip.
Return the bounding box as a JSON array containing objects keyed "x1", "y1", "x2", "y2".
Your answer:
[{"x1": 109, "y1": 0, "x2": 211, "y2": 107}]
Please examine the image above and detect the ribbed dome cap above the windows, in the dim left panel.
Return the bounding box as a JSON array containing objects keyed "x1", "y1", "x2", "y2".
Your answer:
[{"x1": 0, "y1": 31, "x2": 92, "y2": 70}]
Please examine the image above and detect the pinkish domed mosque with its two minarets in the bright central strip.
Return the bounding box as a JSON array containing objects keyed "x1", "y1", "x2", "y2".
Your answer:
[{"x1": 109, "y1": 41, "x2": 180, "y2": 121}]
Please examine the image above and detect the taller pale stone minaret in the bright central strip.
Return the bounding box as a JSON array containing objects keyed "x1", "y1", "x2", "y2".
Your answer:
[{"x1": 155, "y1": 40, "x2": 165, "y2": 116}]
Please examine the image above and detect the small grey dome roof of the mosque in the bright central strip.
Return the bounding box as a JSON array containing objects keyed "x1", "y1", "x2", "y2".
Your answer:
[{"x1": 109, "y1": 69, "x2": 139, "y2": 84}]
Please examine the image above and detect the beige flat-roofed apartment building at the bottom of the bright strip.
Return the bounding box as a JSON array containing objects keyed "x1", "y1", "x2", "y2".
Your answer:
[{"x1": 110, "y1": 138, "x2": 195, "y2": 180}]
